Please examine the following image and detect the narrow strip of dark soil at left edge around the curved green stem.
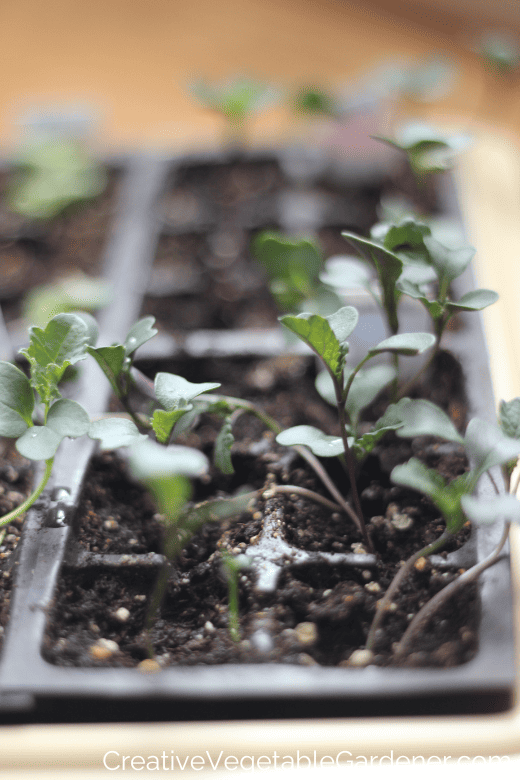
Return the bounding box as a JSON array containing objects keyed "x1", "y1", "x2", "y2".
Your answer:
[{"x1": 0, "y1": 439, "x2": 32, "y2": 649}]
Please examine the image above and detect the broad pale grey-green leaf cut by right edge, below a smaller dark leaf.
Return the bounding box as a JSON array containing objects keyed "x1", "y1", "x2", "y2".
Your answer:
[{"x1": 464, "y1": 417, "x2": 520, "y2": 479}]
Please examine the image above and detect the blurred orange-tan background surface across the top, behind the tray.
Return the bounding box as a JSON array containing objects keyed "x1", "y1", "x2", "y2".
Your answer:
[{"x1": 0, "y1": 0, "x2": 520, "y2": 146}]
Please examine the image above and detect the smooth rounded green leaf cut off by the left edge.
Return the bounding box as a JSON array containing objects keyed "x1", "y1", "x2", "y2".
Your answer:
[{"x1": 0, "y1": 360, "x2": 34, "y2": 438}]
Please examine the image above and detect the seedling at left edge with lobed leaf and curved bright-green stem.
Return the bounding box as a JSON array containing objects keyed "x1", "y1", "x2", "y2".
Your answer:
[{"x1": 0, "y1": 314, "x2": 97, "y2": 525}]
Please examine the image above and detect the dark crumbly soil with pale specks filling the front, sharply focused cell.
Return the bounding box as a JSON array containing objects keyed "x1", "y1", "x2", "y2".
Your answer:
[{"x1": 45, "y1": 358, "x2": 479, "y2": 667}]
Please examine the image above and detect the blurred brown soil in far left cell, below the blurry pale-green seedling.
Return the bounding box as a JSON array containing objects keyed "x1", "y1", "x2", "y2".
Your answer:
[{"x1": 0, "y1": 170, "x2": 120, "y2": 322}]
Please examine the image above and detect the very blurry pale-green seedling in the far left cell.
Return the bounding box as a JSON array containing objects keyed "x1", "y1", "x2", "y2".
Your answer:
[{"x1": 6, "y1": 136, "x2": 107, "y2": 220}]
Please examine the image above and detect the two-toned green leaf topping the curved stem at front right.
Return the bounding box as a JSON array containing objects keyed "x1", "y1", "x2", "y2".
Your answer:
[{"x1": 390, "y1": 458, "x2": 471, "y2": 534}]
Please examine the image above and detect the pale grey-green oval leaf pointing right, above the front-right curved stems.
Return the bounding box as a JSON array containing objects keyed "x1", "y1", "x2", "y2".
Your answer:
[{"x1": 387, "y1": 398, "x2": 464, "y2": 444}]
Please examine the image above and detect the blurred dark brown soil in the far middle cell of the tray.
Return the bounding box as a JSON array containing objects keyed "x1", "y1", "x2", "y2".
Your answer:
[{"x1": 141, "y1": 160, "x2": 382, "y2": 332}]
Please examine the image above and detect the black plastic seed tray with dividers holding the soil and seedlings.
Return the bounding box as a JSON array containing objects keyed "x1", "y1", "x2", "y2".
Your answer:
[{"x1": 0, "y1": 145, "x2": 514, "y2": 722}]
